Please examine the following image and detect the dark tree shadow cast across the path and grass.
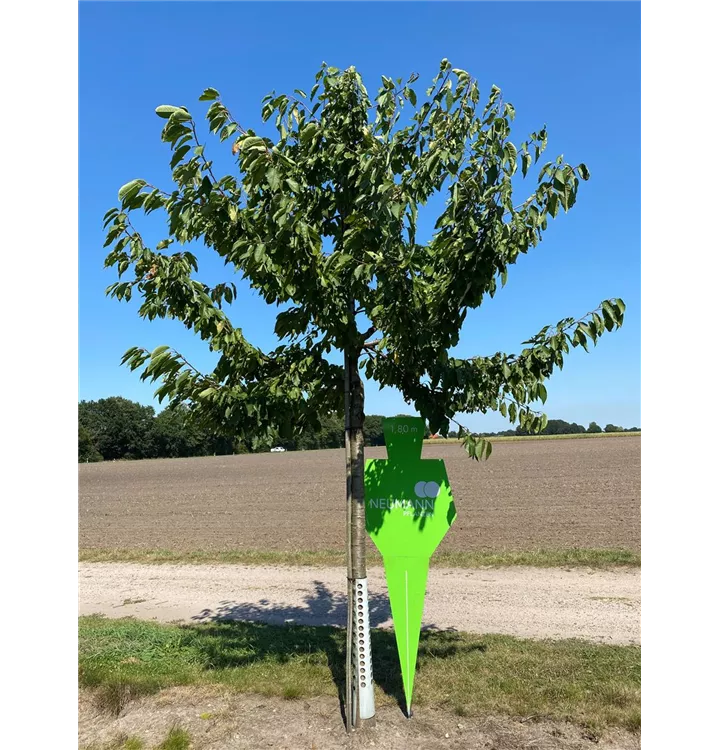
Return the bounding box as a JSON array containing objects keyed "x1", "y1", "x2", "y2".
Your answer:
[{"x1": 187, "y1": 581, "x2": 484, "y2": 720}]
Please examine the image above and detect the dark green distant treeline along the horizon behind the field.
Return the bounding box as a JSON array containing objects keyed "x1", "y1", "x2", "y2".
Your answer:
[{"x1": 78, "y1": 396, "x2": 640, "y2": 463}]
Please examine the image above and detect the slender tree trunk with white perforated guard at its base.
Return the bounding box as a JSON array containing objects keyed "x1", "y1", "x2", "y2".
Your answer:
[{"x1": 344, "y1": 353, "x2": 374, "y2": 731}]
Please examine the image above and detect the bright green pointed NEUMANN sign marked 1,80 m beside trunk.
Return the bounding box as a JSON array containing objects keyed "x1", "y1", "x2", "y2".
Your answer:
[{"x1": 364, "y1": 417, "x2": 456, "y2": 716}]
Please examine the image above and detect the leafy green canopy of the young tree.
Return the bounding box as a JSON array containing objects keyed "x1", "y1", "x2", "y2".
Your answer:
[{"x1": 105, "y1": 60, "x2": 625, "y2": 458}]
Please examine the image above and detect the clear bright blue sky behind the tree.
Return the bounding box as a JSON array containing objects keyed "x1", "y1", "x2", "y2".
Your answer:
[{"x1": 79, "y1": 0, "x2": 641, "y2": 431}]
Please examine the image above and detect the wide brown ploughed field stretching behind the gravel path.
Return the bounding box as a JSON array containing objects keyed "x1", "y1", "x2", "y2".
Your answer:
[{"x1": 79, "y1": 437, "x2": 641, "y2": 551}]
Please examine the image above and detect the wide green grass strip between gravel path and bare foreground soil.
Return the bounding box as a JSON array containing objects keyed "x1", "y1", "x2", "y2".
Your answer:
[{"x1": 78, "y1": 616, "x2": 641, "y2": 736}]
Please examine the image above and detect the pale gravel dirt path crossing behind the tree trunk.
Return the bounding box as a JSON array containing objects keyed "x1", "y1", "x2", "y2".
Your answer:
[{"x1": 79, "y1": 563, "x2": 641, "y2": 644}]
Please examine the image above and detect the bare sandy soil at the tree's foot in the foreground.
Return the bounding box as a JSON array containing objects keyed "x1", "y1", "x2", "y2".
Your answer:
[{"x1": 79, "y1": 687, "x2": 640, "y2": 750}]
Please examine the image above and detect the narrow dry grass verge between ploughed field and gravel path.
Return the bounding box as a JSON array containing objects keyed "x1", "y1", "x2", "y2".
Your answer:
[{"x1": 79, "y1": 547, "x2": 641, "y2": 568}]
